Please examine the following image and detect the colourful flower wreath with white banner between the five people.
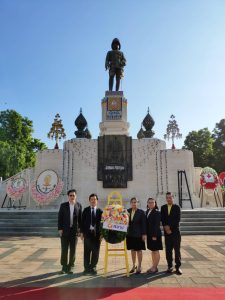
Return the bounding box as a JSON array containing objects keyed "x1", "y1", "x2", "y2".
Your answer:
[{"x1": 101, "y1": 204, "x2": 129, "y2": 244}]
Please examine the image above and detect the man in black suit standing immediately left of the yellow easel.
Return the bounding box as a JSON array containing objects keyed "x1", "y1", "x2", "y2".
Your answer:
[{"x1": 81, "y1": 194, "x2": 102, "y2": 275}]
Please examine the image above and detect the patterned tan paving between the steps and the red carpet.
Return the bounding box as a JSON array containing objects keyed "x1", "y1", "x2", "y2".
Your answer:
[{"x1": 0, "y1": 236, "x2": 225, "y2": 288}]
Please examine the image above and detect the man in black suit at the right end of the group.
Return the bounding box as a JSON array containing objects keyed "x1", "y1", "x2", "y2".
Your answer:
[{"x1": 161, "y1": 192, "x2": 182, "y2": 275}]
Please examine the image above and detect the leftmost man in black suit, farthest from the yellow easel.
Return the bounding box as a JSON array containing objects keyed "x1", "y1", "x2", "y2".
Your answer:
[{"x1": 58, "y1": 189, "x2": 82, "y2": 274}]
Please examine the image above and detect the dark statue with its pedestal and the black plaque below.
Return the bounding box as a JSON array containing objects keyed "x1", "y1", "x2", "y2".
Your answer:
[{"x1": 98, "y1": 39, "x2": 133, "y2": 188}]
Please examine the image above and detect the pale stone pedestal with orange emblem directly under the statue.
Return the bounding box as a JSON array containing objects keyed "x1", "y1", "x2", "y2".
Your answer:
[{"x1": 99, "y1": 91, "x2": 130, "y2": 136}]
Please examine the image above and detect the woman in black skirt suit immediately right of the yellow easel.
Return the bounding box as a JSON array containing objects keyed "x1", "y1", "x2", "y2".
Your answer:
[{"x1": 126, "y1": 198, "x2": 146, "y2": 274}]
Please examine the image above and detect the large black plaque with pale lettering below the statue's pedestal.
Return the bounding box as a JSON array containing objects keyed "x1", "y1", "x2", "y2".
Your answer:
[{"x1": 98, "y1": 135, "x2": 133, "y2": 188}]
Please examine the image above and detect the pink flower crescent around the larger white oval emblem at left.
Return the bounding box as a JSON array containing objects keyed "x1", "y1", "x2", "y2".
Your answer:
[{"x1": 31, "y1": 179, "x2": 63, "y2": 205}]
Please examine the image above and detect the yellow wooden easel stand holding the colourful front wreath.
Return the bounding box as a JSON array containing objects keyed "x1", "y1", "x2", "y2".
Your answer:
[{"x1": 104, "y1": 192, "x2": 130, "y2": 277}]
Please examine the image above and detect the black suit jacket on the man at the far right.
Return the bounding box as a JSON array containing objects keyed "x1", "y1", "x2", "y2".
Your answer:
[{"x1": 161, "y1": 204, "x2": 181, "y2": 232}]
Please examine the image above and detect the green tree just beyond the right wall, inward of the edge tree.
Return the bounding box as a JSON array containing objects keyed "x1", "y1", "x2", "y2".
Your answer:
[{"x1": 183, "y1": 128, "x2": 215, "y2": 168}]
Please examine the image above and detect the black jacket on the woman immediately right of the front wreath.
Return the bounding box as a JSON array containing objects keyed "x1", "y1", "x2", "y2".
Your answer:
[{"x1": 127, "y1": 208, "x2": 146, "y2": 237}]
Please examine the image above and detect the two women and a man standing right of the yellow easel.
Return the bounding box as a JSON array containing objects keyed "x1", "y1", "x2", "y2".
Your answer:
[{"x1": 126, "y1": 192, "x2": 182, "y2": 275}]
